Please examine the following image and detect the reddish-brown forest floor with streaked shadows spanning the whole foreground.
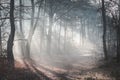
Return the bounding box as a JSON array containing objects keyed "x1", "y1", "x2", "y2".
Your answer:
[{"x1": 0, "y1": 57, "x2": 120, "y2": 80}]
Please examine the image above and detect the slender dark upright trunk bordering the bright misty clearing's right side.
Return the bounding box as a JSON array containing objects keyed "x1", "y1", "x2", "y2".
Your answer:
[{"x1": 102, "y1": 0, "x2": 108, "y2": 60}]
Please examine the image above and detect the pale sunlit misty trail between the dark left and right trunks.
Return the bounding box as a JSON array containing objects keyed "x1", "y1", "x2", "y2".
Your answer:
[{"x1": 14, "y1": 47, "x2": 111, "y2": 80}]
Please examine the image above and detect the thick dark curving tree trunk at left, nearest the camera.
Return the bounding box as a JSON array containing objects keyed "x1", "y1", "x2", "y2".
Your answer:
[{"x1": 7, "y1": 0, "x2": 15, "y2": 66}]
